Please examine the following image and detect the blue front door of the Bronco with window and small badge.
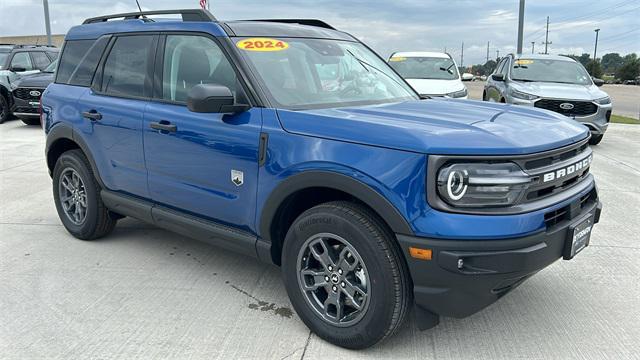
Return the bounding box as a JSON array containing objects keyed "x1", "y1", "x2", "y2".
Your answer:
[{"x1": 144, "y1": 35, "x2": 262, "y2": 232}]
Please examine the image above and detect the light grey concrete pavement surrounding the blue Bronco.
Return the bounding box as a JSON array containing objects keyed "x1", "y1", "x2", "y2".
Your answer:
[{"x1": 0, "y1": 121, "x2": 640, "y2": 360}]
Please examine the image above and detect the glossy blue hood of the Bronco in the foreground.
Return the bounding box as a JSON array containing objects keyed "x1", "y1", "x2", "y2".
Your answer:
[{"x1": 278, "y1": 98, "x2": 589, "y2": 155}]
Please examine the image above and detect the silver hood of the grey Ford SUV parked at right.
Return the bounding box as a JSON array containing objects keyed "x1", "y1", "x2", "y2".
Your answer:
[{"x1": 512, "y1": 81, "x2": 607, "y2": 101}]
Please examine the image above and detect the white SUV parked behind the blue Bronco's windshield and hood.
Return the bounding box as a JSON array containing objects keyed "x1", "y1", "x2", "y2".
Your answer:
[{"x1": 389, "y1": 51, "x2": 468, "y2": 99}]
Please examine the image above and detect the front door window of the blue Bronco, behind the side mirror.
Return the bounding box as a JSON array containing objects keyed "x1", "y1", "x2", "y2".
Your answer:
[{"x1": 162, "y1": 35, "x2": 237, "y2": 102}]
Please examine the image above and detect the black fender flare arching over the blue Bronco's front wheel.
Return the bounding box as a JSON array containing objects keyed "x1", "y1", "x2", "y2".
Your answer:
[{"x1": 260, "y1": 170, "x2": 413, "y2": 244}]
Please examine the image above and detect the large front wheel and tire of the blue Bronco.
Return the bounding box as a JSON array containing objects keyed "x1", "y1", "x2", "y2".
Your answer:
[{"x1": 282, "y1": 201, "x2": 412, "y2": 349}]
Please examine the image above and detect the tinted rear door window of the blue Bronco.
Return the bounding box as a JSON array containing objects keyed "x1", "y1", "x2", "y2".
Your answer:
[{"x1": 102, "y1": 35, "x2": 155, "y2": 97}]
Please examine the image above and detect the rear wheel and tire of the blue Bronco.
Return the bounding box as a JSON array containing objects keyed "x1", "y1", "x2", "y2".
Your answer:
[{"x1": 53, "y1": 150, "x2": 117, "y2": 240}]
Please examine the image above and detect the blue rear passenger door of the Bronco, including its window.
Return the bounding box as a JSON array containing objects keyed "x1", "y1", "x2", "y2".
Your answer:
[{"x1": 75, "y1": 34, "x2": 158, "y2": 198}]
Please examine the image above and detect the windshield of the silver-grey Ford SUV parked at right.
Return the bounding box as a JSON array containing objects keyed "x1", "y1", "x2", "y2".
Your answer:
[{"x1": 511, "y1": 59, "x2": 592, "y2": 85}]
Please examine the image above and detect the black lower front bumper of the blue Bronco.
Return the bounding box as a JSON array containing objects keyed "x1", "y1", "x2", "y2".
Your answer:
[{"x1": 397, "y1": 188, "x2": 602, "y2": 320}]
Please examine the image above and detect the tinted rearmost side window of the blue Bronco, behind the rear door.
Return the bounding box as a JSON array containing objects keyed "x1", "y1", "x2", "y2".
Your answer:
[{"x1": 56, "y1": 37, "x2": 109, "y2": 86}]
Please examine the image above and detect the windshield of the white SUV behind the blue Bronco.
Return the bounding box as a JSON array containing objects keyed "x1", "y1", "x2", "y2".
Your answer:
[{"x1": 389, "y1": 56, "x2": 458, "y2": 80}]
